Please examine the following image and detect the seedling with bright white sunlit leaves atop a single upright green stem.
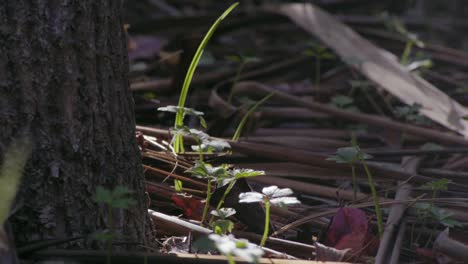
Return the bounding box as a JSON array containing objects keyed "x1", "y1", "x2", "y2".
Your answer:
[{"x1": 239, "y1": 185, "x2": 301, "y2": 247}]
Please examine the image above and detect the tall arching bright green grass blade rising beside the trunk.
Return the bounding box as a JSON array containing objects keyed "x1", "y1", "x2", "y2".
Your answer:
[{"x1": 174, "y1": 2, "x2": 239, "y2": 153}]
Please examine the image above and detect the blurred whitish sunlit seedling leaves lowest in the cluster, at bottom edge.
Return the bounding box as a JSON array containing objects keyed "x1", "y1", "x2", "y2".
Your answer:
[{"x1": 208, "y1": 234, "x2": 263, "y2": 264}]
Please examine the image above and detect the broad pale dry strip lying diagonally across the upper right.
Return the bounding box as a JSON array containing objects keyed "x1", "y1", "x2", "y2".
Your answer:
[{"x1": 266, "y1": 4, "x2": 468, "y2": 137}]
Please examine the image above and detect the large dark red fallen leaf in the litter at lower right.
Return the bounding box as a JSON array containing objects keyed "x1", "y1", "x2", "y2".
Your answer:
[{"x1": 326, "y1": 207, "x2": 378, "y2": 255}]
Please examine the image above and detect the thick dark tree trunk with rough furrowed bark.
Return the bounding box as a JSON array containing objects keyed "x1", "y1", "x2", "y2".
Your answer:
[{"x1": 0, "y1": 0, "x2": 146, "y2": 246}]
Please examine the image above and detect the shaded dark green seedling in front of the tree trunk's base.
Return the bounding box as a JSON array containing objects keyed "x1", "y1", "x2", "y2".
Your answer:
[{"x1": 94, "y1": 185, "x2": 136, "y2": 264}]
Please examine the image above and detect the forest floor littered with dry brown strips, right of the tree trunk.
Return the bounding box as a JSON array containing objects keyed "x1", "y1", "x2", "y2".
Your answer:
[{"x1": 128, "y1": 1, "x2": 468, "y2": 263}]
